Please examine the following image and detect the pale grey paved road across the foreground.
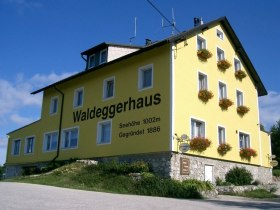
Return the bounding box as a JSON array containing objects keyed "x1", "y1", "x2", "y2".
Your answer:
[{"x1": 0, "y1": 182, "x2": 280, "y2": 210}]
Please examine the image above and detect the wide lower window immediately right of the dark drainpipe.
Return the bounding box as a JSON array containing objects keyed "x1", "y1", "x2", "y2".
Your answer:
[{"x1": 61, "y1": 128, "x2": 79, "y2": 149}]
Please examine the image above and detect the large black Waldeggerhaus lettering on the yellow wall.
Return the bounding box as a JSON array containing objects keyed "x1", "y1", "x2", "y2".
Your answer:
[{"x1": 73, "y1": 93, "x2": 161, "y2": 123}]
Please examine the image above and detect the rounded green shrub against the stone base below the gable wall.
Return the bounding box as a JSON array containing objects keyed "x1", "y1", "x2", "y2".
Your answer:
[{"x1": 226, "y1": 167, "x2": 253, "y2": 185}]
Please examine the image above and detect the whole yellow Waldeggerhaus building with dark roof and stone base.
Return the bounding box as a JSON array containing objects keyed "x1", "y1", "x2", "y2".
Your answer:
[{"x1": 5, "y1": 17, "x2": 271, "y2": 182}]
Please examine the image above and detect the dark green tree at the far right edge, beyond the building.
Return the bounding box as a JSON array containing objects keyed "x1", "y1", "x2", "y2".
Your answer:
[{"x1": 270, "y1": 120, "x2": 280, "y2": 167}]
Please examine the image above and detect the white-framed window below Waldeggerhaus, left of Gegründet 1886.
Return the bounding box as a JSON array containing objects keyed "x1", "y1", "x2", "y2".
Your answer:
[{"x1": 97, "y1": 120, "x2": 112, "y2": 144}]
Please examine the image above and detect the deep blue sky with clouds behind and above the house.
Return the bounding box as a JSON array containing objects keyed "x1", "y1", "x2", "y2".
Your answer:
[{"x1": 0, "y1": 0, "x2": 280, "y2": 165}]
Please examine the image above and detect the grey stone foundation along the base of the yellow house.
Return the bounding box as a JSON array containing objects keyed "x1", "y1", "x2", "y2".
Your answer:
[{"x1": 3, "y1": 152, "x2": 272, "y2": 184}]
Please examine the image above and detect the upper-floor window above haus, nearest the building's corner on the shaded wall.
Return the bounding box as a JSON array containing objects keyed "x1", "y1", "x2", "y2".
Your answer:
[{"x1": 138, "y1": 65, "x2": 153, "y2": 89}]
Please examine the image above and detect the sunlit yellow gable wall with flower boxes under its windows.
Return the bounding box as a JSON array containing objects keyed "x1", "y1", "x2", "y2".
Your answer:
[{"x1": 173, "y1": 25, "x2": 261, "y2": 165}]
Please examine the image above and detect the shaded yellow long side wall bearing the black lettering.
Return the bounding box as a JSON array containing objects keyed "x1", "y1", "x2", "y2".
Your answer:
[{"x1": 6, "y1": 45, "x2": 170, "y2": 164}]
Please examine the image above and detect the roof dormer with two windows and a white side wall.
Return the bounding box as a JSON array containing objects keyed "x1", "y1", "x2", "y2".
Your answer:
[{"x1": 81, "y1": 42, "x2": 142, "y2": 70}]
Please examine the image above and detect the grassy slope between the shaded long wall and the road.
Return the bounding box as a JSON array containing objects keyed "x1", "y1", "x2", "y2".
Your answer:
[{"x1": 3, "y1": 162, "x2": 213, "y2": 198}]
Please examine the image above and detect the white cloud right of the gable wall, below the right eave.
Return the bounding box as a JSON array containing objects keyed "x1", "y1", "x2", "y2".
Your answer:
[{"x1": 259, "y1": 91, "x2": 280, "y2": 130}]
